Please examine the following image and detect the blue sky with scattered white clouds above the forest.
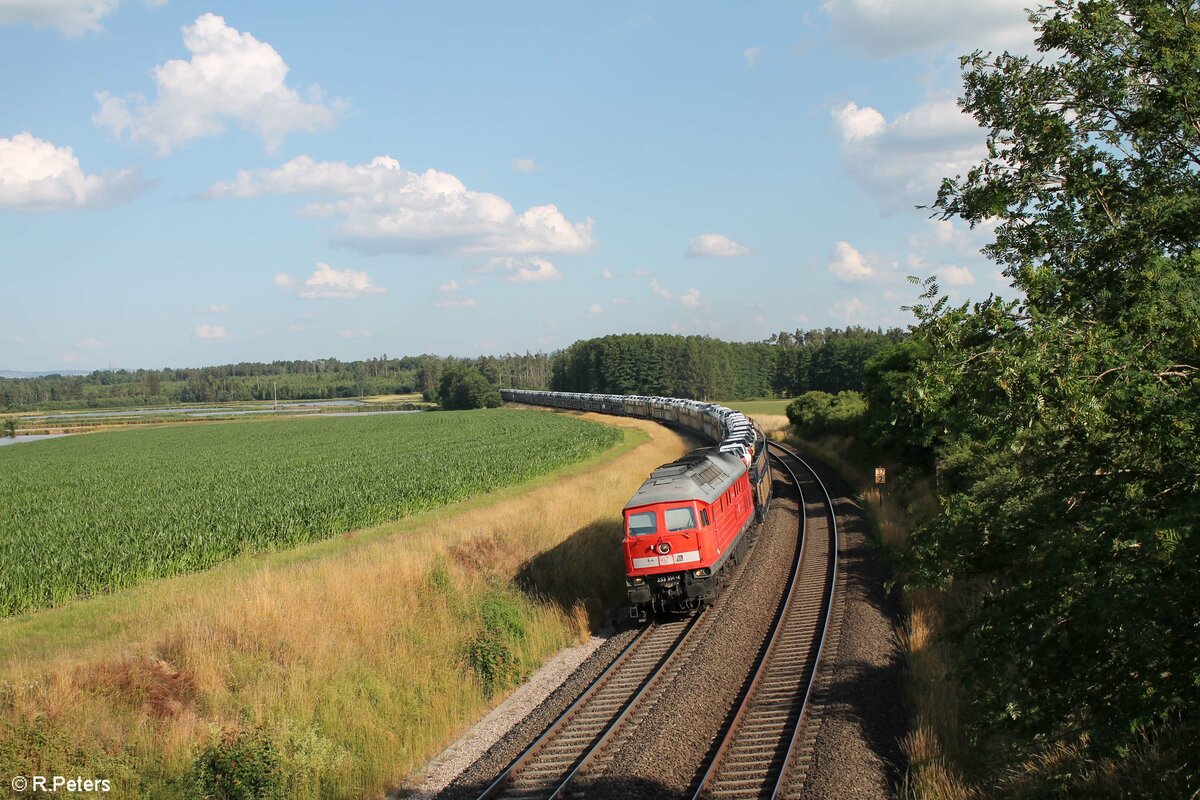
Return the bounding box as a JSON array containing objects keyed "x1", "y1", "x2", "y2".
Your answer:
[{"x1": 0, "y1": 0, "x2": 1031, "y2": 371}]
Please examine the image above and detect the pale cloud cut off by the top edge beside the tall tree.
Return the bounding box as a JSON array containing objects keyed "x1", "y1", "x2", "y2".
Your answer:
[{"x1": 821, "y1": 0, "x2": 1038, "y2": 59}]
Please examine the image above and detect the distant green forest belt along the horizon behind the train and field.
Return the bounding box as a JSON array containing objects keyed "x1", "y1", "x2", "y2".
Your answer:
[{"x1": 0, "y1": 327, "x2": 905, "y2": 410}]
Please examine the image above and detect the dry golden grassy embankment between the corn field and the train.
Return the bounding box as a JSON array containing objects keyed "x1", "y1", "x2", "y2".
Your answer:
[{"x1": 0, "y1": 410, "x2": 689, "y2": 798}]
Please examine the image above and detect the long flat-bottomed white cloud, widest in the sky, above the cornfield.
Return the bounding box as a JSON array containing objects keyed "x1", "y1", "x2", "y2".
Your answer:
[{"x1": 212, "y1": 156, "x2": 595, "y2": 255}]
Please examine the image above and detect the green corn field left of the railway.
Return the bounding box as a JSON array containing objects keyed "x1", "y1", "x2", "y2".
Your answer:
[{"x1": 0, "y1": 409, "x2": 622, "y2": 616}]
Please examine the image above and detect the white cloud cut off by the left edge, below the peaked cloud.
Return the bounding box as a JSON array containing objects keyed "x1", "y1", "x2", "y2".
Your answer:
[{"x1": 0, "y1": 132, "x2": 151, "y2": 211}]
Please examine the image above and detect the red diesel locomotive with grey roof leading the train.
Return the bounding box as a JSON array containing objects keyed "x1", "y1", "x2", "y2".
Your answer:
[{"x1": 624, "y1": 439, "x2": 770, "y2": 619}]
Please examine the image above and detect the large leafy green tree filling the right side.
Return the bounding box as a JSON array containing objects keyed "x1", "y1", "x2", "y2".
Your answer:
[{"x1": 904, "y1": 0, "x2": 1200, "y2": 796}]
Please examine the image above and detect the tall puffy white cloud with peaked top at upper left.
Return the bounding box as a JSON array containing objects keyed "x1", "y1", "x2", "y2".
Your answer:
[{"x1": 92, "y1": 13, "x2": 340, "y2": 155}]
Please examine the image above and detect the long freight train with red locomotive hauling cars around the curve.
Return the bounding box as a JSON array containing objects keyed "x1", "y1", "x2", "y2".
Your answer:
[{"x1": 500, "y1": 389, "x2": 772, "y2": 619}]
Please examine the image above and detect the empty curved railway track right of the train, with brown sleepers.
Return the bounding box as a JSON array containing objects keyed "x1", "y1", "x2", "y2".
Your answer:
[{"x1": 694, "y1": 443, "x2": 839, "y2": 800}]
